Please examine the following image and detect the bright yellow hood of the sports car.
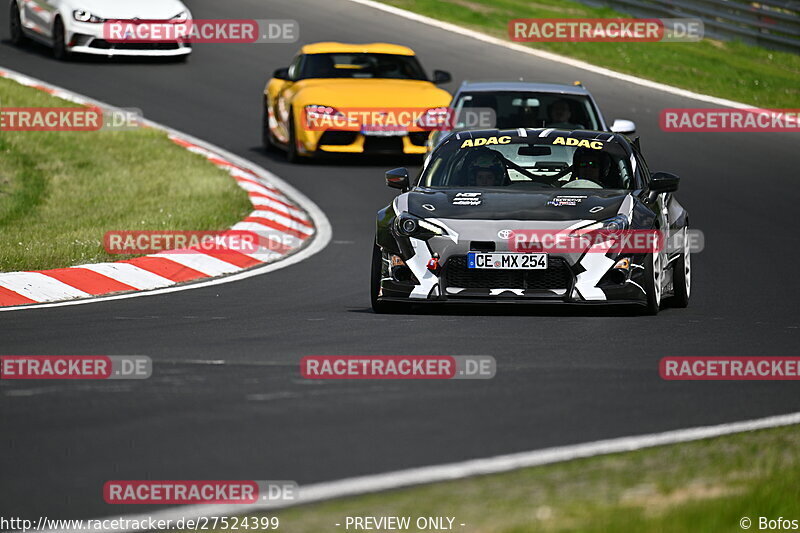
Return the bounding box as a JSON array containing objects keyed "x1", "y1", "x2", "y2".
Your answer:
[{"x1": 295, "y1": 78, "x2": 451, "y2": 108}]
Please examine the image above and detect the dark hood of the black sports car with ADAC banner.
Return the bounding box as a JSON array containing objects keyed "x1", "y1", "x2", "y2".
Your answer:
[{"x1": 406, "y1": 188, "x2": 630, "y2": 221}]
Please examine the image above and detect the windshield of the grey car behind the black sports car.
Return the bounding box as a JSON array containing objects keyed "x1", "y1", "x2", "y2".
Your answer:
[{"x1": 455, "y1": 91, "x2": 603, "y2": 130}]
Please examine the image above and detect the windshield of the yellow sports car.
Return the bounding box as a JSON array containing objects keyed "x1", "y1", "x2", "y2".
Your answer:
[{"x1": 300, "y1": 53, "x2": 428, "y2": 80}]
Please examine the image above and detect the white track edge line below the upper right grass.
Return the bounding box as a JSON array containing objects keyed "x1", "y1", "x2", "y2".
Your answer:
[{"x1": 347, "y1": 0, "x2": 756, "y2": 109}]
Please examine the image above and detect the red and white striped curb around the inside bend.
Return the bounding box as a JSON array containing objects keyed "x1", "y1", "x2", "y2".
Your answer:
[{"x1": 0, "y1": 68, "x2": 331, "y2": 310}]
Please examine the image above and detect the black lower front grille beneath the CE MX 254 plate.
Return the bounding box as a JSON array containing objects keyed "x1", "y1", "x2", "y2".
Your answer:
[{"x1": 444, "y1": 255, "x2": 572, "y2": 290}]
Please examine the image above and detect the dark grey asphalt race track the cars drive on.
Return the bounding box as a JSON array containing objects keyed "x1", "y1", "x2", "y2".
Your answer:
[{"x1": 0, "y1": 0, "x2": 800, "y2": 518}]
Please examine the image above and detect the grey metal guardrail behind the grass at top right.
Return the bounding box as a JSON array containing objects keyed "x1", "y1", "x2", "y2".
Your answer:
[{"x1": 581, "y1": 0, "x2": 800, "y2": 54}]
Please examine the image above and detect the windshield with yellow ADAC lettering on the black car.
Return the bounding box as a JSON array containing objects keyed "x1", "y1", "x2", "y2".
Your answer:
[{"x1": 419, "y1": 134, "x2": 634, "y2": 189}]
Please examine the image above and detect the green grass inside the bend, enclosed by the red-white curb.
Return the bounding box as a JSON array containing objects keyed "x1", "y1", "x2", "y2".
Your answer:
[{"x1": 0, "y1": 79, "x2": 250, "y2": 272}]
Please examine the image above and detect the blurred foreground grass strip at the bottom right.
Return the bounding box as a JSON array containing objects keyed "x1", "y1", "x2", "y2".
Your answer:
[{"x1": 203, "y1": 426, "x2": 800, "y2": 533}]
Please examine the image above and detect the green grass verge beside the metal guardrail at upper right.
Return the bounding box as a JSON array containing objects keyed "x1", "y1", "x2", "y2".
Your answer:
[{"x1": 382, "y1": 0, "x2": 800, "y2": 108}]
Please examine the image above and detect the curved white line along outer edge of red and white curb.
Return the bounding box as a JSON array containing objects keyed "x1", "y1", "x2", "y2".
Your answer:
[{"x1": 0, "y1": 67, "x2": 333, "y2": 312}]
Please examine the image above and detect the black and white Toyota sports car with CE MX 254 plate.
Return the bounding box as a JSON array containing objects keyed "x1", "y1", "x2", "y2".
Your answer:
[{"x1": 371, "y1": 128, "x2": 691, "y2": 314}]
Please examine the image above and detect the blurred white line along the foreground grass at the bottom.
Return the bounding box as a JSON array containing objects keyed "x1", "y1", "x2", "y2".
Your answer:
[{"x1": 42, "y1": 412, "x2": 800, "y2": 533}]
